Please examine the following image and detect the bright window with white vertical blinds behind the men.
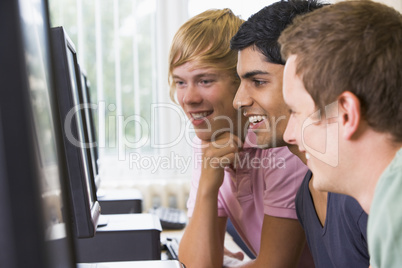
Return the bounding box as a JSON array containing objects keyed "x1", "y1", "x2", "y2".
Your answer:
[{"x1": 49, "y1": 0, "x2": 273, "y2": 182}]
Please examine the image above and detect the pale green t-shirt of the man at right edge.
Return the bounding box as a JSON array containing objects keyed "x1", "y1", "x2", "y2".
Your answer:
[{"x1": 367, "y1": 149, "x2": 402, "y2": 268}]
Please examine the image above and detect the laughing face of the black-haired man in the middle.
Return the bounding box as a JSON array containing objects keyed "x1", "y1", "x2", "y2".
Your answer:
[{"x1": 233, "y1": 46, "x2": 289, "y2": 148}]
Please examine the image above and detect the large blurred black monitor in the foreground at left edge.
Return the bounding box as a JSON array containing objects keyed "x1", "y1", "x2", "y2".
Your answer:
[{"x1": 0, "y1": 0, "x2": 75, "y2": 268}]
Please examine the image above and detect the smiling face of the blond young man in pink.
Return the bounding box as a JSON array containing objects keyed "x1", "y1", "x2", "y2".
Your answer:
[{"x1": 173, "y1": 62, "x2": 243, "y2": 141}]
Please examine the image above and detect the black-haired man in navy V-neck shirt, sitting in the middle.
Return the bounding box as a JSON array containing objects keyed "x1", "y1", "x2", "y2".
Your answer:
[{"x1": 231, "y1": 0, "x2": 369, "y2": 268}]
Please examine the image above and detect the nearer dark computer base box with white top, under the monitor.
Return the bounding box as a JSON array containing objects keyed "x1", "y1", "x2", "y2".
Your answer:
[{"x1": 75, "y1": 214, "x2": 162, "y2": 263}]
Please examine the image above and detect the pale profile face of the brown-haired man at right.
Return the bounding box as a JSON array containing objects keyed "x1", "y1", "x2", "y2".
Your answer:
[{"x1": 283, "y1": 56, "x2": 339, "y2": 191}]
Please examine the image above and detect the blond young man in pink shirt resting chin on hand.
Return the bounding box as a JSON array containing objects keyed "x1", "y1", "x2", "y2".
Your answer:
[{"x1": 169, "y1": 9, "x2": 307, "y2": 268}]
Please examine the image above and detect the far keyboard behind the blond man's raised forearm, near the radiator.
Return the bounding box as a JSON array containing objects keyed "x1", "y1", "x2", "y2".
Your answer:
[{"x1": 149, "y1": 207, "x2": 187, "y2": 230}]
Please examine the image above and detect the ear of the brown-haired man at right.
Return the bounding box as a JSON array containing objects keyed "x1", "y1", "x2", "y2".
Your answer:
[{"x1": 338, "y1": 91, "x2": 361, "y2": 140}]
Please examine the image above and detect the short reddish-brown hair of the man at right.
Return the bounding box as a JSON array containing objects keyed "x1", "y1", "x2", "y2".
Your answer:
[{"x1": 279, "y1": 1, "x2": 402, "y2": 142}]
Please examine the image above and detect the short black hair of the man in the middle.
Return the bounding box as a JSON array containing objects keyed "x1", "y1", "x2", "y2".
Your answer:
[{"x1": 230, "y1": 0, "x2": 325, "y2": 65}]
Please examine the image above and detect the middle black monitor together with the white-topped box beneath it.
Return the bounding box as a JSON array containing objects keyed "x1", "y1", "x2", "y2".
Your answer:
[{"x1": 51, "y1": 27, "x2": 161, "y2": 262}]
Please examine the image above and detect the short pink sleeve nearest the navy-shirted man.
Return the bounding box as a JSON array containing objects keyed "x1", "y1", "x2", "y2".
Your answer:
[{"x1": 263, "y1": 147, "x2": 308, "y2": 219}]
